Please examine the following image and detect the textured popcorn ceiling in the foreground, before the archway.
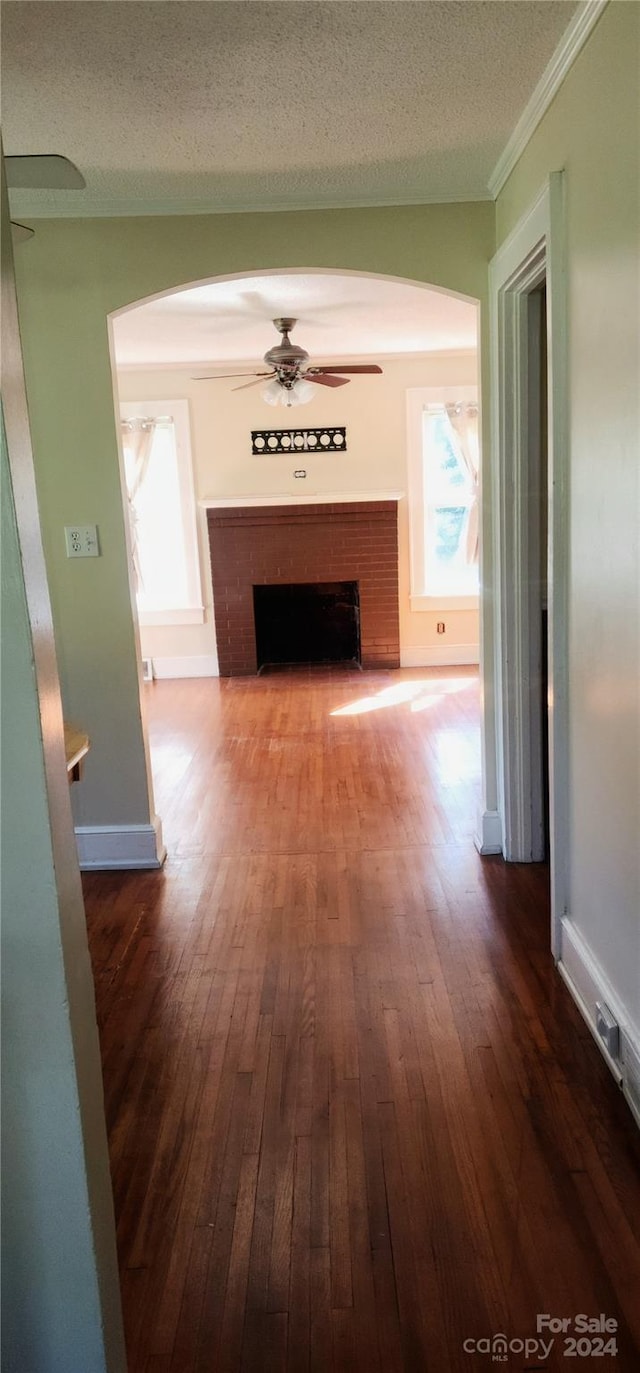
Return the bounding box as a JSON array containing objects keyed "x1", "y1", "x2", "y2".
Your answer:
[{"x1": 1, "y1": 0, "x2": 575, "y2": 216}]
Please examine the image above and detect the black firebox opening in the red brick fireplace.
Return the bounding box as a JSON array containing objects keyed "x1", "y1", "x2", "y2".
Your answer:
[{"x1": 253, "y1": 582, "x2": 360, "y2": 671}]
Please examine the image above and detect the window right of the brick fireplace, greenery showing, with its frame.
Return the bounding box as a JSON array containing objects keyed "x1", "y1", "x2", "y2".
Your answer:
[{"x1": 408, "y1": 387, "x2": 479, "y2": 610}]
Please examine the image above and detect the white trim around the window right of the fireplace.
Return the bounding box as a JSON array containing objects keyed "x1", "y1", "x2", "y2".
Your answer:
[{"x1": 407, "y1": 384, "x2": 479, "y2": 611}]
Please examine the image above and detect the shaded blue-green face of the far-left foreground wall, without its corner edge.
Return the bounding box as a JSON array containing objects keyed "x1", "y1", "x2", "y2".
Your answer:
[{"x1": 0, "y1": 427, "x2": 124, "y2": 1373}]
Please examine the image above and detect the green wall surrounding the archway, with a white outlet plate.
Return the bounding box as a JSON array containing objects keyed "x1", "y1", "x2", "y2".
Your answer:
[{"x1": 16, "y1": 203, "x2": 494, "y2": 825}]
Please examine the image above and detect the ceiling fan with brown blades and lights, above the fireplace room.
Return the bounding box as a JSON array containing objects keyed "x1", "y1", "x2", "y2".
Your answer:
[{"x1": 194, "y1": 319, "x2": 382, "y2": 405}]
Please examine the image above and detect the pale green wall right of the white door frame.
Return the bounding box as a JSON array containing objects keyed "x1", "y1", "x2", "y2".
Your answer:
[{"x1": 496, "y1": 0, "x2": 640, "y2": 1027}]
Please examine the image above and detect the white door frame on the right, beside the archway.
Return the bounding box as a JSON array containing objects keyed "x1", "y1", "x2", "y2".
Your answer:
[{"x1": 489, "y1": 172, "x2": 570, "y2": 958}]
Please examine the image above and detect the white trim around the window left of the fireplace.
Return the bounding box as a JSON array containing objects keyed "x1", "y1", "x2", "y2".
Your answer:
[{"x1": 119, "y1": 400, "x2": 205, "y2": 627}]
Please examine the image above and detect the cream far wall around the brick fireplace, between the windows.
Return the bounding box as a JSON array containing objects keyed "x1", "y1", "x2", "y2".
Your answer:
[{"x1": 118, "y1": 353, "x2": 478, "y2": 666}]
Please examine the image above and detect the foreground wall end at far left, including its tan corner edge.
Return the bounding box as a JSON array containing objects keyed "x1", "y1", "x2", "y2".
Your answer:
[{"x1": 0, "y1": 157, "x2": 126, "y2": 1373}]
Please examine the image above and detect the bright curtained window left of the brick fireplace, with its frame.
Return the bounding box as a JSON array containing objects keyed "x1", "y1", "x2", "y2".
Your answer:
[{"x1": 121, "y1": 401, "x2": 203, "y2": 625}]
